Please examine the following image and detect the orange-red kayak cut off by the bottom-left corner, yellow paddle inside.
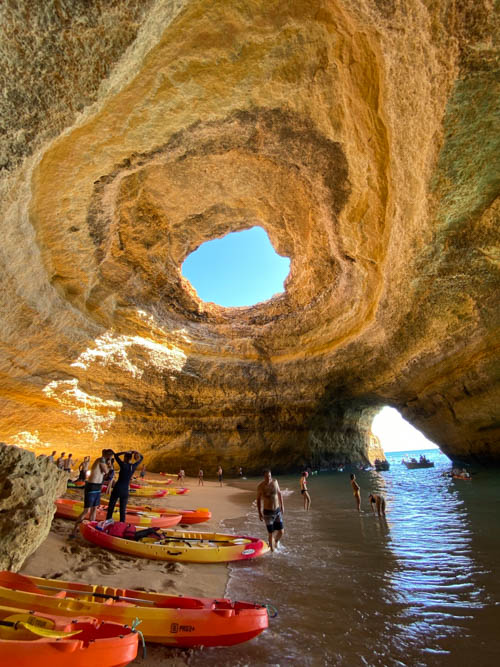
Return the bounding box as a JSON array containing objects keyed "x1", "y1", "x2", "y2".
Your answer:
[{"x1": 0, "y1": 606, "x2": 139, "y2": 667}]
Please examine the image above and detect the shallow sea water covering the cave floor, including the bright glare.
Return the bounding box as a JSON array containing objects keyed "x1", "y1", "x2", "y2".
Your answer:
[{"x1": 190, "y1": 450, "x2": 500, "y2": 667}]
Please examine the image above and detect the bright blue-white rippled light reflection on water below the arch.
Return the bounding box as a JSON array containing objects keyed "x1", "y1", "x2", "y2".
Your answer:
[{"x1": 380, "y1": 454, "x2": 483, "y2": 664}]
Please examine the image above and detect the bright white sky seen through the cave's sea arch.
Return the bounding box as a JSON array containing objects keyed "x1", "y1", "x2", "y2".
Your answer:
[{"x1": 371, "y1": 405, "x2": 439, "y2": 454}]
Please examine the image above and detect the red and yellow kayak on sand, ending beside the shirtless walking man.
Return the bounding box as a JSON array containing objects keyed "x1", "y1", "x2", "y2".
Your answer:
[{"x1": 80, "y1": 521, "x2": 269, "y2": 563}]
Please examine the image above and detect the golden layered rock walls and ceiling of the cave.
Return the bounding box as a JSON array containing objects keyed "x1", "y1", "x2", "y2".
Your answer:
[{"x1": 0, "y1": 0, "x2": 500, "y2": 473}]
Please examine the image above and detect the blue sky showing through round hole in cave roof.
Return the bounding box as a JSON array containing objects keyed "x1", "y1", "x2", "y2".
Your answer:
[{"x1": 182, "y1": 227, "x2": 290, "y2": 308}]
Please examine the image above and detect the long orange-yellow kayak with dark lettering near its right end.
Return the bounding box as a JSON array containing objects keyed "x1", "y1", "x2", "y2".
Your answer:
[{"x1": 0, "y1": 571, "x2": 268, "y2": 648}]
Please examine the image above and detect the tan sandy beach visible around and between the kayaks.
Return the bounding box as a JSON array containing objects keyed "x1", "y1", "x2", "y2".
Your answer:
[{"x1": 21, "y1": 473, "x2": 251, "y2": 667}]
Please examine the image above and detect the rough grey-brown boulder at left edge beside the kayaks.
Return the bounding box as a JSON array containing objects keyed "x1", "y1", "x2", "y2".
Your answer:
[{"x1": 0, "y1": 442, "x2": 68, "y2": 571}]
